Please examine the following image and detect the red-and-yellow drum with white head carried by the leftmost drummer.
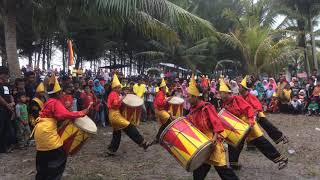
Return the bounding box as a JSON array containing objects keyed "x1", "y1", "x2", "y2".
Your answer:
[{"x1": 58, "y1": 116, "x2": 97, "y2": 155}]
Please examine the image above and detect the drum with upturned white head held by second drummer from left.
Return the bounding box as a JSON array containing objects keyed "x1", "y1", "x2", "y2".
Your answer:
[{"x1": 121, "y1": 94, "x2": 143, "y2": 125}]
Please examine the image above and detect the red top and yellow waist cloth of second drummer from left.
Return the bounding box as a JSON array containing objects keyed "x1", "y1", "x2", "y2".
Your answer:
[{"x1": 107, "y1": 91, "x2": 130, "y2": 131}]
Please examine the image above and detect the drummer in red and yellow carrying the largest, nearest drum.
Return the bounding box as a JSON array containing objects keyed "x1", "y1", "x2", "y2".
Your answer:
[{"x1": 187, "y1": 76, "x2": 238, "y2": 180}]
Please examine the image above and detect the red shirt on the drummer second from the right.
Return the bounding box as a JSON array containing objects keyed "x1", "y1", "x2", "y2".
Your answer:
[{"x1": 222, "y1": 96, "x2": 255, "y2": 126}]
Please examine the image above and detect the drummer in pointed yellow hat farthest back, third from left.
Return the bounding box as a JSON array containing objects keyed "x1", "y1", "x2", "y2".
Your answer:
[{"x1": 153, "y1": 79, "x2": 172, "y2": 142}]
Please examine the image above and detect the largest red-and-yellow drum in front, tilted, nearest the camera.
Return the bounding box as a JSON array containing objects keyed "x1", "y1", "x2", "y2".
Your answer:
[{"x1": 160, "y1": 117, "x2": 213, "y2": 172}]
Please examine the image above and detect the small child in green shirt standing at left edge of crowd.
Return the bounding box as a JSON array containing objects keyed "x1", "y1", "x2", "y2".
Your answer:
[{"x1": 16, "y1": 92, "x2": 31, "y2": 149}]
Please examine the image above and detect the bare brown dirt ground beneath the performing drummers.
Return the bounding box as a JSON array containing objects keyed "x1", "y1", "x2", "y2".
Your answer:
[{"x1": 0, "y1": 114, "x2": 320, "y2": 180}]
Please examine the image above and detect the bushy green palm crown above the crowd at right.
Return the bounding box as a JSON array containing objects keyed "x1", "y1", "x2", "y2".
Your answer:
[{"x1": 220, "y1": 26, "x2": 300, "y2": 74}]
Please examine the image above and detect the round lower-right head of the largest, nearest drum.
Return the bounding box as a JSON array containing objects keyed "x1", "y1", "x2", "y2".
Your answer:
[{"x1": 187, "y1": 141, "x2": 213, "y2": 172}]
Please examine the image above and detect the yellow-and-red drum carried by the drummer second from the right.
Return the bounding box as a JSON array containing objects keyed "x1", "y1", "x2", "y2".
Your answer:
[{"x1": 219, "y1": 109, "x2": 250, "y2": 147}]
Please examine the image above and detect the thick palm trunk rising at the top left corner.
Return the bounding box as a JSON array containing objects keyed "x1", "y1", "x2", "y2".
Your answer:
[{"x1": 4, "y1": 0, "x2": 21, "y2": 78}]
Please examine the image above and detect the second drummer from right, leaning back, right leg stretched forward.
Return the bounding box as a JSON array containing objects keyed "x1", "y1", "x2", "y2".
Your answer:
[{"x1": 219, "y1": 80, "x2": 288, "y2": 169}]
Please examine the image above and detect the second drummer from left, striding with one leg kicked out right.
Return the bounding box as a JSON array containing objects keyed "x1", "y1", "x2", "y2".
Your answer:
[{"x1": 107, "y1": 74, "x2": 151, "y2": 155}]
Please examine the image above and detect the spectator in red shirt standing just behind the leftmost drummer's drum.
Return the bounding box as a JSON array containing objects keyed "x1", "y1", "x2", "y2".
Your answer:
[{"x1": 80, "y1": 85, "x2": 96, "y2": 119}]
